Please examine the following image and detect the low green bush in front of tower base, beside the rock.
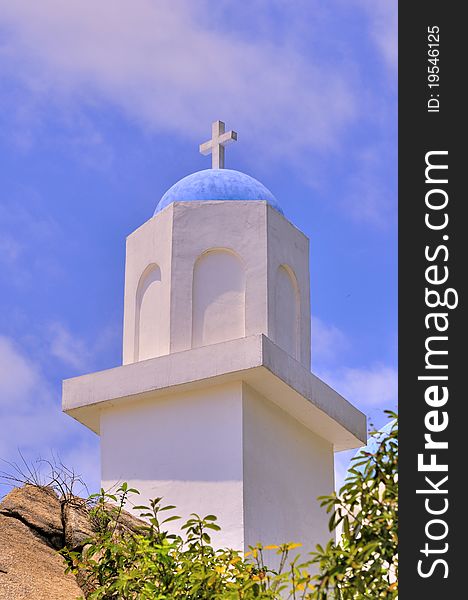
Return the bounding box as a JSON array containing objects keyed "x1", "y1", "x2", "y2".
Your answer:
[{"x1": 65, "y1": 484, "x2": 310, "y2": 600}]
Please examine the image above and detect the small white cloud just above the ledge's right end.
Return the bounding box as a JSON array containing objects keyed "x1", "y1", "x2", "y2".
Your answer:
[{"x1": 319, "y1": 365, "x2": 398, "y2": 411}]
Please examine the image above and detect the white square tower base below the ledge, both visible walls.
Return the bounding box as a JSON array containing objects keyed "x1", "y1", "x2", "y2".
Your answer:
[{"x1": 101, "y1": 382, "x2": 333, "y2": 552}]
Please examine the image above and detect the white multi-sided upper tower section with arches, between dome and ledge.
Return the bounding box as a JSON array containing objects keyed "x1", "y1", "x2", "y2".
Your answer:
[{"x1": 123, "y1": 200, "x2": 310, "y2": 368}]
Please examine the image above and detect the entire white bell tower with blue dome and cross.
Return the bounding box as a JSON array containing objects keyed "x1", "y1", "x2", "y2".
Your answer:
[{"x1": 63, "y1": 122, "x2": 366, "y2": 552}]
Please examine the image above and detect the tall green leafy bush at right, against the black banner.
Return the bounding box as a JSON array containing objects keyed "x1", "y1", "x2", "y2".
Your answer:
[{"x1": 312, "y1": 411, "x2": 398, "y2": 600}]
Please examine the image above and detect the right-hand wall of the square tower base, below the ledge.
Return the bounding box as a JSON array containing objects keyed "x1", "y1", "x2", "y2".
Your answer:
[{"x1": 243, "y1": 385, "x2": 334, "y2": 554}]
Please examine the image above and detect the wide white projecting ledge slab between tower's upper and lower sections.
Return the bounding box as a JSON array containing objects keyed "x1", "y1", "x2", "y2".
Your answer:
[{"x1": 62, "y1": 335, "x2": 367, "y2": 451}]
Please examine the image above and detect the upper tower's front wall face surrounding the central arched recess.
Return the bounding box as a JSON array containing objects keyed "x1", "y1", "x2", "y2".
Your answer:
[{"x1": 171, "y1": 201, "x2": 267, "y2": 352}]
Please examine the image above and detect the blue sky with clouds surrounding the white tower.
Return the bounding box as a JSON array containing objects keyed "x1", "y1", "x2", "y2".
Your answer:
[{"x1": 0, "y1": 0, "x2": 397, "y2": 494}]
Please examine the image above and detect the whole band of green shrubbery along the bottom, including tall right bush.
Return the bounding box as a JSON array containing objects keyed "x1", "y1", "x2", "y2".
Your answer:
[{"x1": 64, "y1": 415, "x2": 398, "y2": 600}]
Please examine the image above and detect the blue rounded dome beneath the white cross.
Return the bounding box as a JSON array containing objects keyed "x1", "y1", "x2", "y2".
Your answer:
[{"x1": 154, "y1": 169, "x2": 283, "y2": 214}]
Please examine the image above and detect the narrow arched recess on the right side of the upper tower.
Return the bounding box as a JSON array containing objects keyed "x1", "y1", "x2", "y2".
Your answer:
[{"x1": 274, "y1": 265, "x2": 300, "y2": 360}]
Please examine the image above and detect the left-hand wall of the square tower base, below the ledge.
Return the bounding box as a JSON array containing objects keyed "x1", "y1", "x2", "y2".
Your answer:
[{"x1": 101, "y1": 383, "x2": 244, "y2": 549}]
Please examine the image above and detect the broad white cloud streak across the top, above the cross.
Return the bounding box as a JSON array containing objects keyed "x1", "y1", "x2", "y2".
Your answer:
[{"x1": 0, "y1": 0, "x2": 356, "y2": 164}]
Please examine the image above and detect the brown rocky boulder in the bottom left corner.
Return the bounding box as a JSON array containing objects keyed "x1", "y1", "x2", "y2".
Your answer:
[{"x1": 0, "y1": 485, "x2": 142, "y2": 600}]
